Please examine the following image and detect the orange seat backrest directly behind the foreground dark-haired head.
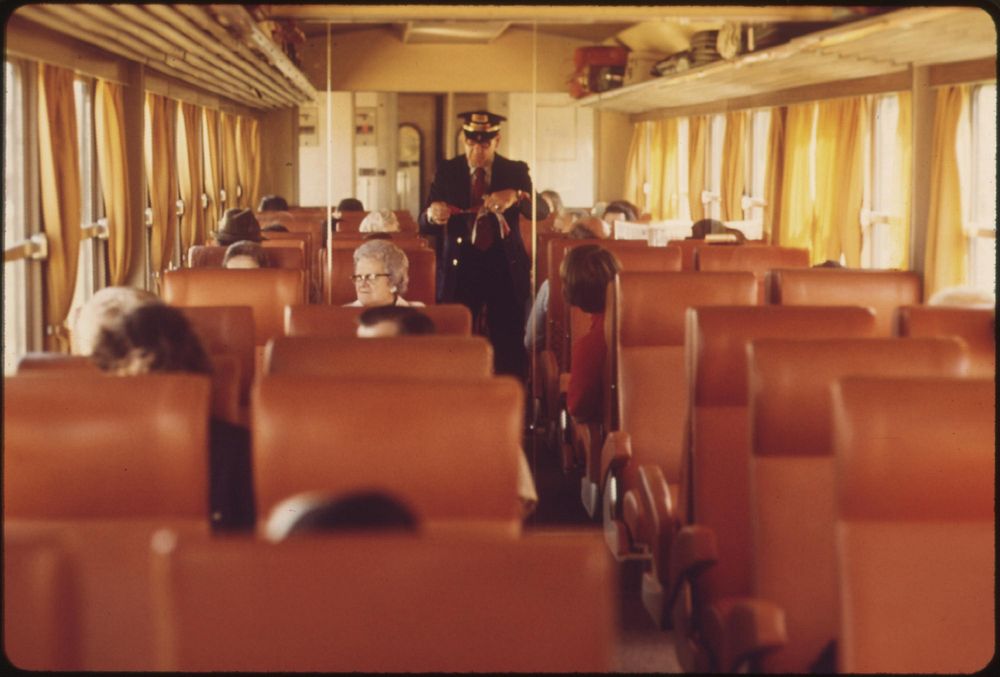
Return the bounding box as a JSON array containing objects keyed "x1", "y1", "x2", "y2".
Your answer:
[{"x1": 252, "y1": 375, "x2": 524, "y2": 531}]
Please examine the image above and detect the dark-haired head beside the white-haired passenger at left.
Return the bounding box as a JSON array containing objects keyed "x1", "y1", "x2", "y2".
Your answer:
[{"x1": 93, "y1": 304, "x2": 212, "y2": 374}]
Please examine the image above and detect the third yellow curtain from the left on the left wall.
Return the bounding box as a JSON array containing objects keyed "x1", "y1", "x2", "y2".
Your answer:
[{"x1": 145, "y1": 93, "x2": 177, "y2": 273}]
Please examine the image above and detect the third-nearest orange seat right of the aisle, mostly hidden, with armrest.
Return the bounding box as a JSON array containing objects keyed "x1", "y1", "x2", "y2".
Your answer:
[{"x1": 664, "y1": 306, "x2": 876, "y2": 670}]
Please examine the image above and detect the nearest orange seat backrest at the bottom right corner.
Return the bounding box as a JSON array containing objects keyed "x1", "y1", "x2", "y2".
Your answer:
[{"x1": 833, "y1": 377, "x2": 996, "y2": 673}]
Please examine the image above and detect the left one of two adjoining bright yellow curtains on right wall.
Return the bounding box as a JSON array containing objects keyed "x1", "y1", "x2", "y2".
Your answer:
[{"x1": 775, "y1": 103, "x2": 822, "y2": 254}]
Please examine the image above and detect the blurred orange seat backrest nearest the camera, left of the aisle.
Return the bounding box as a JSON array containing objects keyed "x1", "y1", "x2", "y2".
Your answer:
[{"x1": 155, "y1": 534, "x2": 615, "y2": 673}]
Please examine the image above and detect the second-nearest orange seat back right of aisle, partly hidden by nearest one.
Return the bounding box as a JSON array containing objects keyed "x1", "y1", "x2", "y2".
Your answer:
[{"x1": 743, "y1": 338, "x2": 968, "y2": 672}]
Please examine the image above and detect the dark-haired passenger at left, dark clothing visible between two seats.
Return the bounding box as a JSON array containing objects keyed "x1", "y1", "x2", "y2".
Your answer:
[{"x1": 93, "y1": 303, "x2": 255, "y2": 530}]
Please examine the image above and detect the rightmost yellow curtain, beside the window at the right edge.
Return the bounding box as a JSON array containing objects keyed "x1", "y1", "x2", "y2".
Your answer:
[{"x1": 924, "y1": 86, "x2": 968, "y2": 298}]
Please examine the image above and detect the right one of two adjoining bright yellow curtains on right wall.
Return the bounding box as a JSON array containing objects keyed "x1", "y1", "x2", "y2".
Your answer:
[{"x1": 812, "y1": 96, "x2": 868, "y2": 268}]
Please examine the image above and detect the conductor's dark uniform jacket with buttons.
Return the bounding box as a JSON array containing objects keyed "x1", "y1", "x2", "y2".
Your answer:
[{"x1": 419, "y1": 155, "x2": 549, "y2": 305}]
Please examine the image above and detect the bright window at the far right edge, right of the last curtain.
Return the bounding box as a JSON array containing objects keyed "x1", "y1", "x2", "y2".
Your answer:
[{"x1": 963, "y1": 84, "x2": 997, "y2": 291}]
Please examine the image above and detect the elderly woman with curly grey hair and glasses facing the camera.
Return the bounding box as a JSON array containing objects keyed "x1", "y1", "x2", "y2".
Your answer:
[{"x1": 346, "y1": 240, "x2": 424, "y2": 308}]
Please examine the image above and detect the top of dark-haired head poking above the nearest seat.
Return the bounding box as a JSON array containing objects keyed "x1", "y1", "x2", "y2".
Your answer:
[{"x1": 265, "y1": 491, "x2": 417, "y2": 542}]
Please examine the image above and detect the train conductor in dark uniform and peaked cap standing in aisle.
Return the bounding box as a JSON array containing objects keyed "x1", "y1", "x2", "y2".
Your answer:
[{"x1": 418, "y1": 110, "x2": 549, "y2": 379}]
